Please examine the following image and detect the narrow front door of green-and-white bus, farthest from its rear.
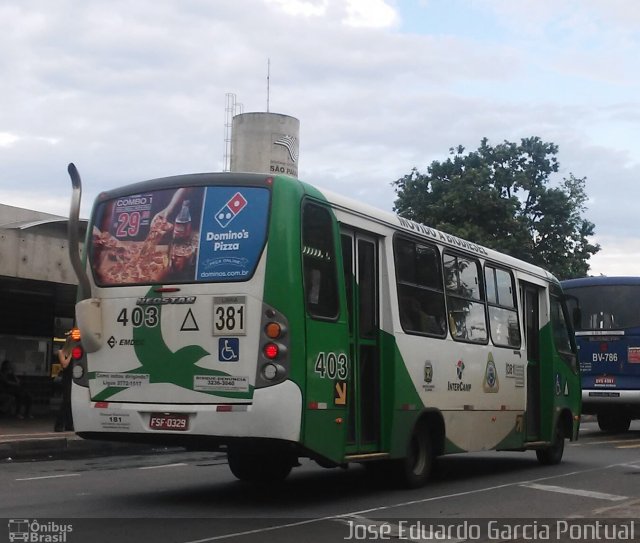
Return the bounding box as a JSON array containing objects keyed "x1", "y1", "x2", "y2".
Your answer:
[{"x1": 520, "y1": 282, "x2": 541, "y2": 441}]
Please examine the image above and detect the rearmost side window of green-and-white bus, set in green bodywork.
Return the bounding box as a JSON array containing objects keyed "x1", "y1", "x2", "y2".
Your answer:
[{"x1": 302, "y1": 203, "x2": 338, "y2": 319}]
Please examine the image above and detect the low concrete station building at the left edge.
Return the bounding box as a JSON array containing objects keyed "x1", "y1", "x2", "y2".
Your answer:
[{"x1": 0, "y1": 204, "x2": 86, "y2": 408}]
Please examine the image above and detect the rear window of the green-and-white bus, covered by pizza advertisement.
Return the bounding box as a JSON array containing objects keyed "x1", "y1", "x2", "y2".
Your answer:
[{"x1": 89, "y1": 186, "x2": 269, "y2": 286}]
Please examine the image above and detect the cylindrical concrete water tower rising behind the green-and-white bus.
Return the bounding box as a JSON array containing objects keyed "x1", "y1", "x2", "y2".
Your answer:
[{"x1": 230, "y1": 113, "x2": 300, "y2": 177}]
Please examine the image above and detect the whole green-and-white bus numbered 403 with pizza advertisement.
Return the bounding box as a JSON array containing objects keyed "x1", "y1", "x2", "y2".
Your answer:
[{"x1": 69, "y1": 165, "x2": 581, "y2": 487}]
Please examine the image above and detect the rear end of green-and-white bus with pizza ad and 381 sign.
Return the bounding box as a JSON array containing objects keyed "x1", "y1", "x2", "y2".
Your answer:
[{"x1": 72, "y1": 174, "x2": 303, "y2": 462}]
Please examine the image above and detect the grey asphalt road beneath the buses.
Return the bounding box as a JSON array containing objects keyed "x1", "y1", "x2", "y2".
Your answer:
[{"x1": 0, "y1": 421, "x2": 640, "y2": 543}]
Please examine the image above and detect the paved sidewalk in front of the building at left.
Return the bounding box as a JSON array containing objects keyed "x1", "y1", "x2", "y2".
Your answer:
[{"x1": 0, "y1": 411, "x2": 158, "y2": 461}]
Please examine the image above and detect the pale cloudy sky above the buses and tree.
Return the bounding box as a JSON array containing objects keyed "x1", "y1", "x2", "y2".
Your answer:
[{"x1": 0, "y1": 0, "x2": 640, "y2": 275}]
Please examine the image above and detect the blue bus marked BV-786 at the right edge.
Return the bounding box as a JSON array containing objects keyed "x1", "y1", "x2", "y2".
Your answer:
[{"x1": 562, "y1": 277, "x2": 640, "y2": 432}]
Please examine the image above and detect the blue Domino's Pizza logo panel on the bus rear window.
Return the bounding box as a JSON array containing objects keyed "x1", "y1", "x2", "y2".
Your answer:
[{"x1": 196, "y1": 187, "x2": 270, "y2": 282}]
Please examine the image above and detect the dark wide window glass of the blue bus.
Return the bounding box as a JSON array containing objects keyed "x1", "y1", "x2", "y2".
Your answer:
[{"x1": 565, "y1": 284, "x2": 640, "y2": 331}]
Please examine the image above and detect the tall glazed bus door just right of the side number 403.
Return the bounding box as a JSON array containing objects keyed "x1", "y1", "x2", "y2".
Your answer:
[{"x1": 341, "y1": 228, "x2": 380, "y2": 454}]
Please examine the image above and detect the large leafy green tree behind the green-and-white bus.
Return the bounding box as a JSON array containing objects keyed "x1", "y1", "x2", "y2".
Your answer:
[{"x1": 392, "y1": 137, "x2": 600, "y2": 279}]
